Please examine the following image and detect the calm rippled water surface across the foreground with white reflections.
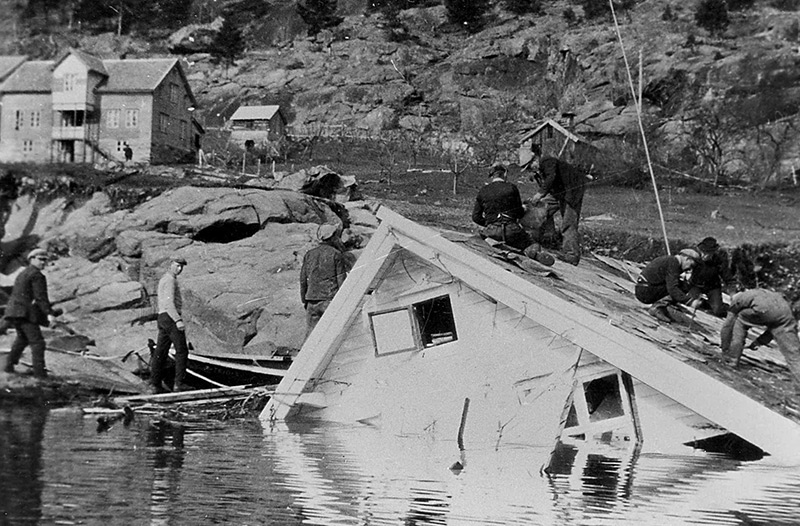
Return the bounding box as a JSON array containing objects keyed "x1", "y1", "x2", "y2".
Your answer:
[{"x1": 0, "y1": 406, "x2": 800, "y2": 526}]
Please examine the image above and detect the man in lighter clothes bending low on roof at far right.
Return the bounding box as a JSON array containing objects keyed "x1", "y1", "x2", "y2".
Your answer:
[{"x1": 720, "y1": 289, "x2": 800, "y2": 384}]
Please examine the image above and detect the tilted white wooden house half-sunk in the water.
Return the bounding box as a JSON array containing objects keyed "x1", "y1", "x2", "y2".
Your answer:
[{"x1": 261, "y1": 207, "x2": 800, "y2": 461}]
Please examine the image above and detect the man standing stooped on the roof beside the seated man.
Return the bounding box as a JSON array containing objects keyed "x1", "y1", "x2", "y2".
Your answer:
[{"x1": 526, "y1": 151, "x2": 589, "y2": 265}]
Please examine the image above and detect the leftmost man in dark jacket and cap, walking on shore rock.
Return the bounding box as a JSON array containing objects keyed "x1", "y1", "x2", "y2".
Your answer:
[{"x1": 3, "y1": 248, "x2": 61, "y2": 378}]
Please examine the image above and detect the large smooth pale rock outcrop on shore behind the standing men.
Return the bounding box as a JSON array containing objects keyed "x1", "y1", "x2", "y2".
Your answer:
[{"x1": 3, "y1": 186, "x2": 376, "y2": 367}]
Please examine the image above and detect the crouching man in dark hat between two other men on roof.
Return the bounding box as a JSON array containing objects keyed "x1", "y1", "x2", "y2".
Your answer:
[{"x1": 689, "y1": 237, "x2": 732, "y2": 317}]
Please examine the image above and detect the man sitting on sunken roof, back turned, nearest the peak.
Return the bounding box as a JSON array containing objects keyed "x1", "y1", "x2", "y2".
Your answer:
[{"x1": 472, "y1": 164, "x2": 531, "y2": 250}]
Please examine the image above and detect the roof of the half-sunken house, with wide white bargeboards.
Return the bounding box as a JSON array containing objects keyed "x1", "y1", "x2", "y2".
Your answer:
[{"x1": 265, "y1": 207, "x2": 800, "y2": 460}]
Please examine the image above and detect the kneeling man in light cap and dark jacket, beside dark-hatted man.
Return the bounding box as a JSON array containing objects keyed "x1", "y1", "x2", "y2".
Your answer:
[{"x1": 635, "y1": 248, "x2": 702, "y2": 323}]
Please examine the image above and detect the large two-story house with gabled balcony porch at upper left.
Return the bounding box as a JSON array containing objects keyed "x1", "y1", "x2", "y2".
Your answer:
[{"x1": 0, "y1": 49, "x2": 199, "y2": 164}]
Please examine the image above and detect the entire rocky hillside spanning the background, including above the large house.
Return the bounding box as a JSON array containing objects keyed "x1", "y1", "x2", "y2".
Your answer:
[{"x1": 0, "y1": 0, "x2": 800, "y2": 185}]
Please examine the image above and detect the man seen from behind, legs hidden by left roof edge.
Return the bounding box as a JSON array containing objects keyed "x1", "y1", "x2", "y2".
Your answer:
[{"x1": 300, "y1": 223, "x2": 350, "y2": 338}]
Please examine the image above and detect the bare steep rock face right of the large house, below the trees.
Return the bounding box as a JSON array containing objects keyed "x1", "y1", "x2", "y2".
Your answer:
[{"x1": 175, "y1": 3, "x2": 800, "y2": 182}]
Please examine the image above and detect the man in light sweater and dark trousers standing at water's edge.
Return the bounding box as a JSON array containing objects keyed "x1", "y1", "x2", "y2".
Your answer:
[{"x1": 150, "y1": 256, "x2": 189, "y2": 394}]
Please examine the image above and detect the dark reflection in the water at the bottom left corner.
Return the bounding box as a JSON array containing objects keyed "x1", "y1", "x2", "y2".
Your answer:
[{"x1": 0, "y1": 406, "x2": 47, "y2": 525}]
